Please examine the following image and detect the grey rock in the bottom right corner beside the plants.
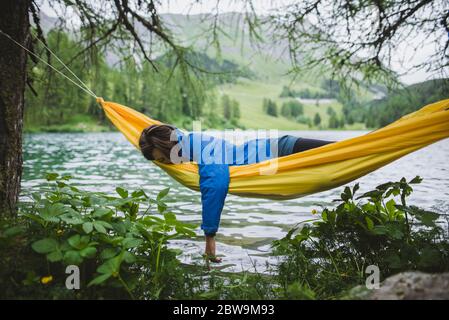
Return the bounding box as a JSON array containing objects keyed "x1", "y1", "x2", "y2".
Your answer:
[{"x1": 364, "y1": 272, "x2": 449, "y2": 300}]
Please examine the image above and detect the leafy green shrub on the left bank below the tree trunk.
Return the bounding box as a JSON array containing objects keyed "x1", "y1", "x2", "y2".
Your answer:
[{"x1": 0, "y1": 174, "x2": 195, "y2": 299}]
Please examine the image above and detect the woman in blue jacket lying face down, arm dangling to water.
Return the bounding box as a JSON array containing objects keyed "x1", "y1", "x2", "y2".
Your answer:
[{"x1": 139, "y1": 125, "x2": 333, "y2": 263}]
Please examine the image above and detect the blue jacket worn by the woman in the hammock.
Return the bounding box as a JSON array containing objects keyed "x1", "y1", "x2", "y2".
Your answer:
[{"x1": 177, "y1": 130, "x2": 297, "y2": 235}]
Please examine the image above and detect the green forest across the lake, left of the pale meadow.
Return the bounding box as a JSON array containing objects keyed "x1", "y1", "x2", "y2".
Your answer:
[{"x1": 25, "y1": 29, "x2": 247, "y2": 131}]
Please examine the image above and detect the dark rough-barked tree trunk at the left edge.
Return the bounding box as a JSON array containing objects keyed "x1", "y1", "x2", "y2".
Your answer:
[{"x1": 0, "y1": 0, "x2": 30, "y2": 216}]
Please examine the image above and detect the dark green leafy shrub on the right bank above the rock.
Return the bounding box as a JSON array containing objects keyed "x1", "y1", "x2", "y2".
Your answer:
[{"x1": 273, "y1": 177, "x2": 449, "y2": 298}]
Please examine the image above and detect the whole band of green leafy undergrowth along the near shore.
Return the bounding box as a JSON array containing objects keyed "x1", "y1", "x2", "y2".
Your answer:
[{"x1": 0, "y1": 174, "x2": 449, "y2": 299}]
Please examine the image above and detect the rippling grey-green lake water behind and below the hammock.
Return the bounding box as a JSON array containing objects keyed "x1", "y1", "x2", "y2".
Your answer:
[{"x1": 22, "y1": 131, "x2": 449, "y2": 271}]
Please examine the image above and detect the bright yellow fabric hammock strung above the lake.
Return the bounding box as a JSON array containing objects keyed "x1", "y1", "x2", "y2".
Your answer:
[{"x1": 98, "y1": 98, "x2": 449, "y2": 199}]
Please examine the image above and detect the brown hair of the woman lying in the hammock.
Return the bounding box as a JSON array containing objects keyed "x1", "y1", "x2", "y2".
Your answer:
[{"x1": 139, "y1": 124, "x2": 178, "y2": 160}]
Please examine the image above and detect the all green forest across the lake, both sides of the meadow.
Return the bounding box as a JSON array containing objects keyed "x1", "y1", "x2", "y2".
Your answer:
[{"x1": 24, "y1": 29, "x2": 449, "y2": 132}]
